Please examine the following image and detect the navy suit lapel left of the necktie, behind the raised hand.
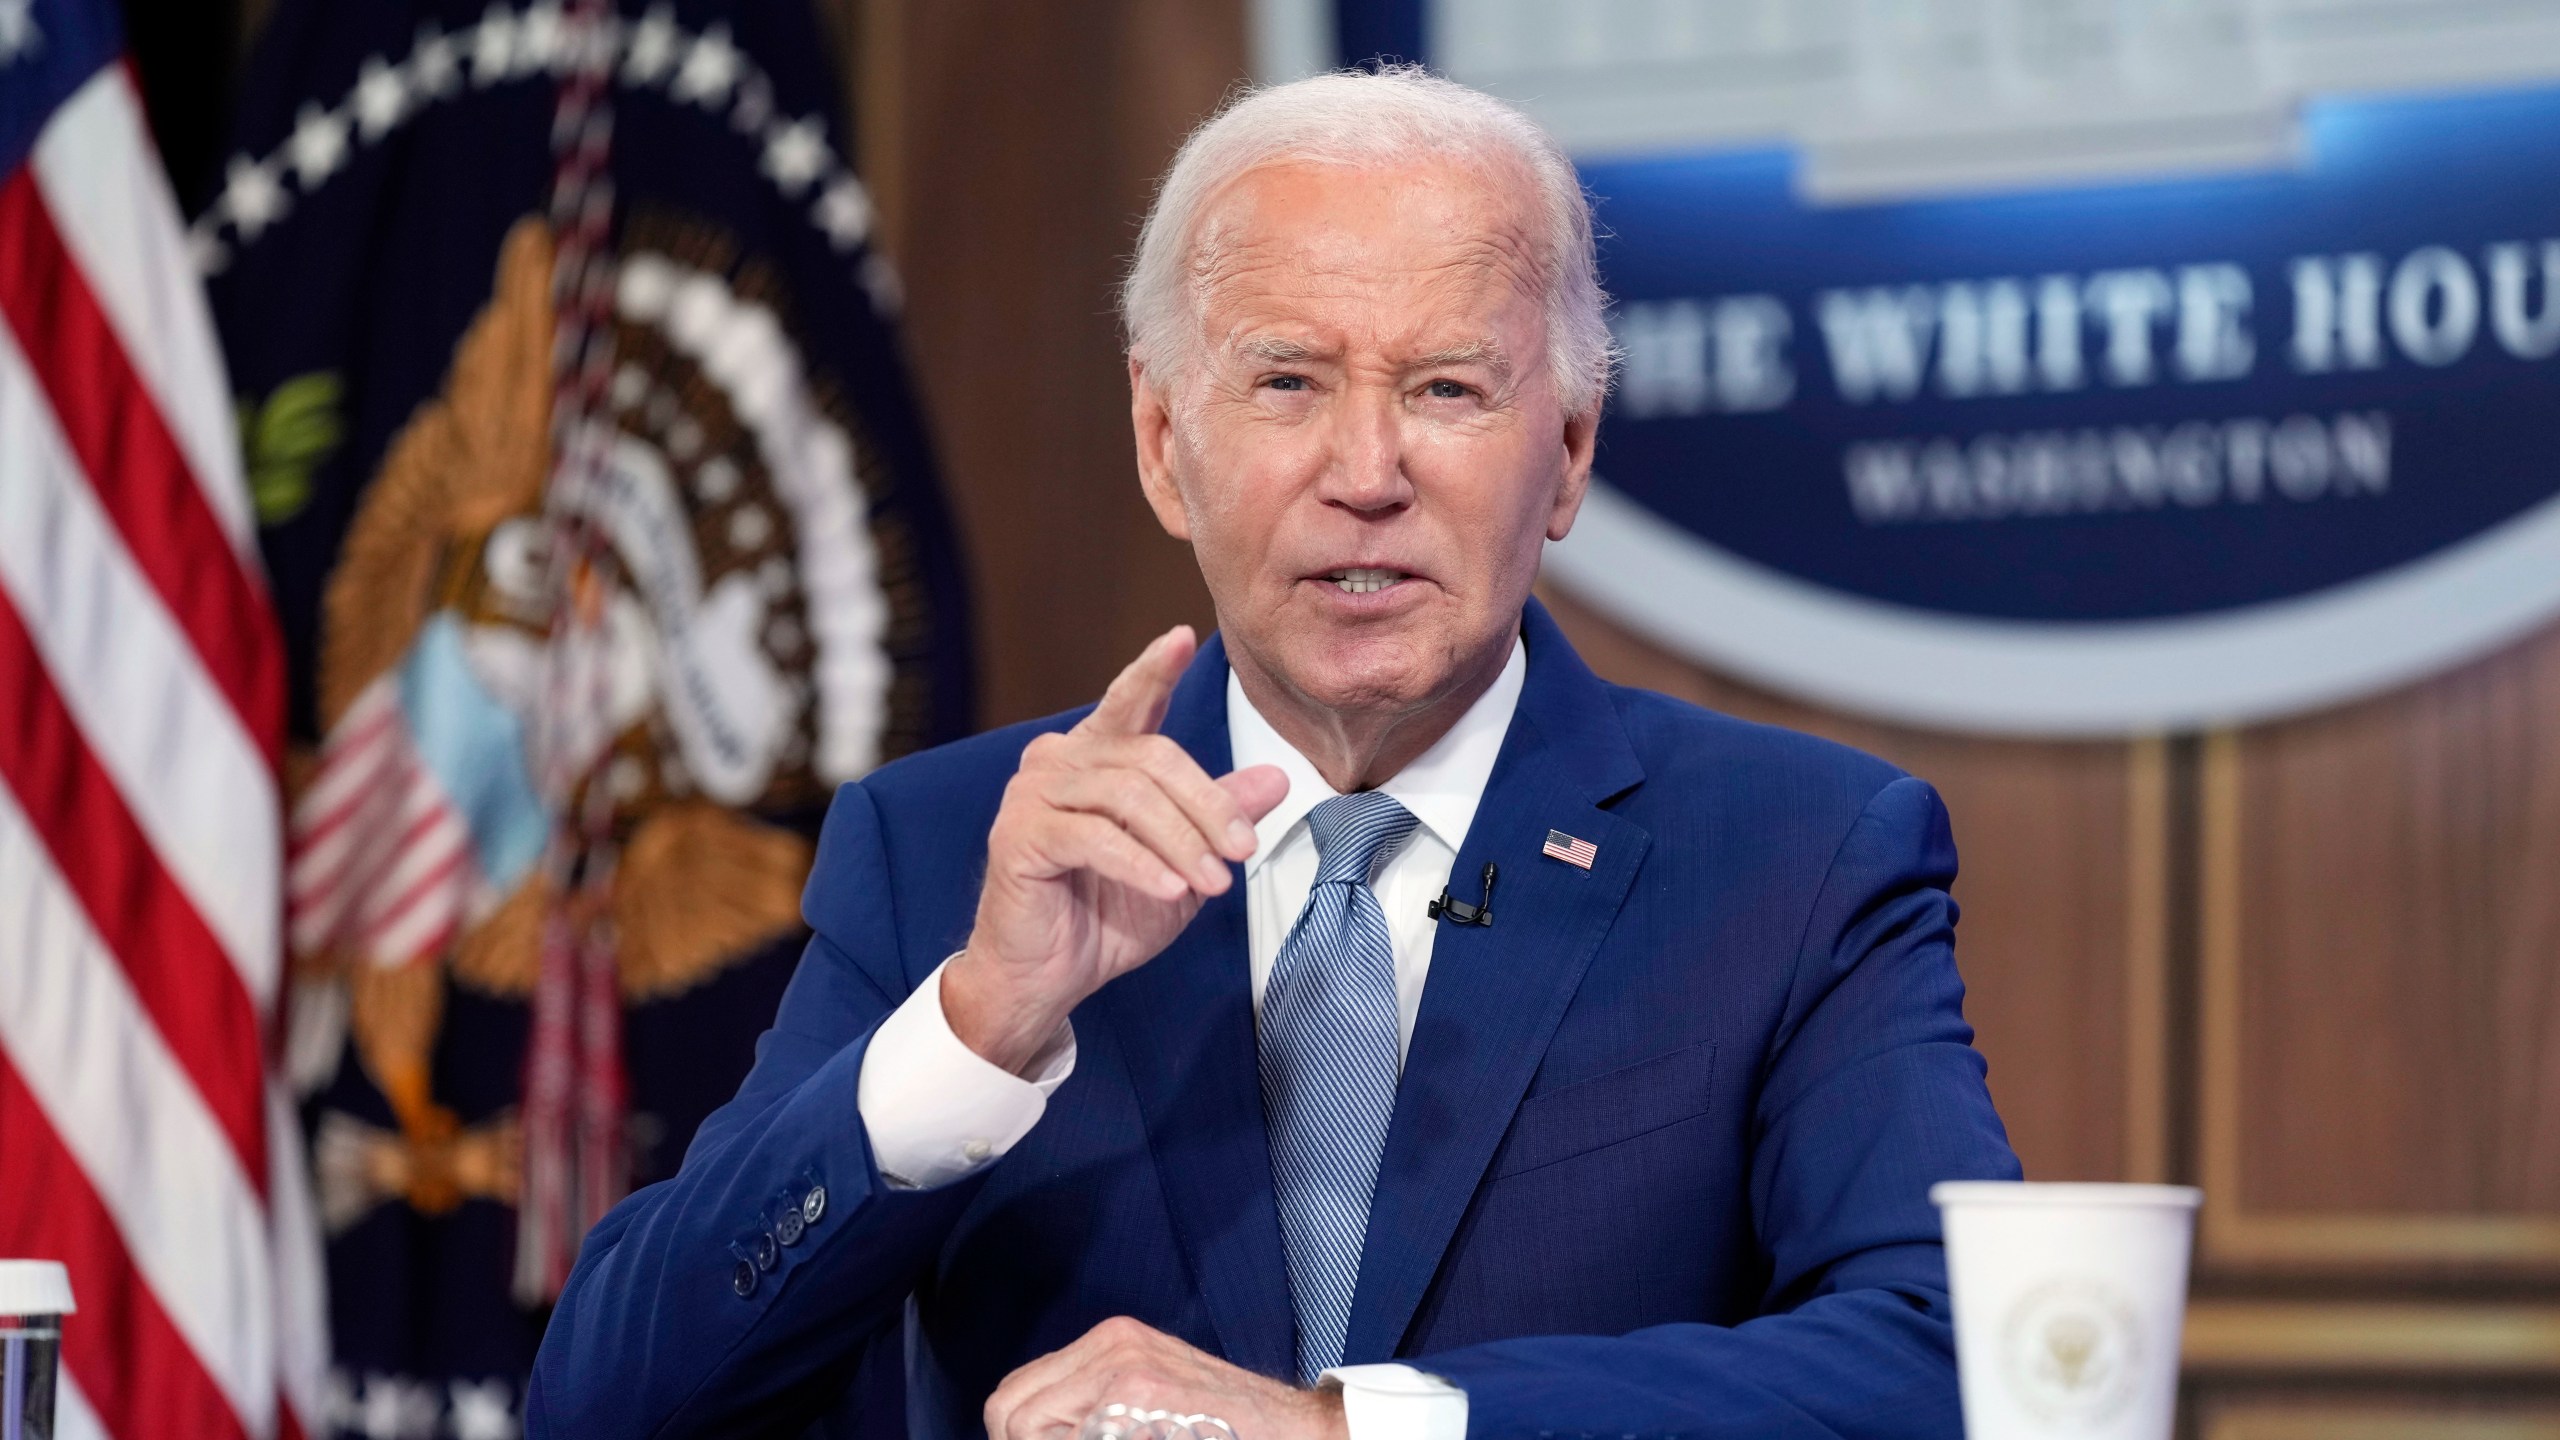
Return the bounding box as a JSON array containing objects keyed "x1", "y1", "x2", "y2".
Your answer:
[{"x1": 1096, "y1": 635, "x2": 1295, "y2": 1376}]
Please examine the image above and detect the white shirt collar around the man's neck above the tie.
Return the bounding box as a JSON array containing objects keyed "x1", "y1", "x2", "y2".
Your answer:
[{"x1": 1226, "y1": 641, "x2": 1528, "y2": 874}]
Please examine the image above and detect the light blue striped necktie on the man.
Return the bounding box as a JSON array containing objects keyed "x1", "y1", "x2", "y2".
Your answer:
[{"x1": 1262, "y1": 792, "x2": 1416, "y2": 1384}]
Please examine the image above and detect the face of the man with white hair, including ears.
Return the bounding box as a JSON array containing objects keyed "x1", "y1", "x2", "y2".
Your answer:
[{"x1": 1132, "y1": 164, "x2": 1597, "y2": 715}]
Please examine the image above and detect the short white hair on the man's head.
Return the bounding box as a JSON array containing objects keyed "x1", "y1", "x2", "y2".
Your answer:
[{"x1": 1121, "y1": 64, "x2": 1618, "y2": 415}]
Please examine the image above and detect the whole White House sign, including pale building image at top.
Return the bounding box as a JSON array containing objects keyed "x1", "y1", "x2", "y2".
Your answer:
[{"x1": 1300, "y1": 0, "x2": 2560, "y2": 735}]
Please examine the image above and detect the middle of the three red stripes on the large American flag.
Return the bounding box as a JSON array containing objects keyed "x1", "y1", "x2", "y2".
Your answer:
[{"x1": 0, "y1": 584, "x2": 266, "y2": 1189}]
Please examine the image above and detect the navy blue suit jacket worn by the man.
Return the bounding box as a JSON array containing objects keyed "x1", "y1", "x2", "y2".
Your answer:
[{"x1": 527, "y1": 602, "x2": 2017, "y2": 1440}]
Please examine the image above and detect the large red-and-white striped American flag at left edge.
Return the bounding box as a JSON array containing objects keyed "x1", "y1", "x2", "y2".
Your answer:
[{"x1": 0, "y1": 0, "x2": 325, "y2": 1440}]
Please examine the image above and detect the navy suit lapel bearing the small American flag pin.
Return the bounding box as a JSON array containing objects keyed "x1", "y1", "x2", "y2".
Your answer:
[{"x1": 1341, "y1": 600, "x2": 1651, "y2": 1363}]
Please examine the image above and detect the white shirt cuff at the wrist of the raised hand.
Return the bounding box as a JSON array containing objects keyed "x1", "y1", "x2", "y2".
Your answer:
[{"x1": 855, "y1": 961, "x2": 1075, "y2": 1189}]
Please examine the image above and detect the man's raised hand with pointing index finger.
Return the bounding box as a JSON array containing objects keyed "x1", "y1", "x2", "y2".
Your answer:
[{"x1": 942, "y1": 625, "x2": 1288, "y2": 1074}]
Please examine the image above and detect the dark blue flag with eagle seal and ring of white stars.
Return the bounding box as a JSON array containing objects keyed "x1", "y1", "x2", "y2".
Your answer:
[{"x1": 189, "y1": 0, "x2": 970, "y2": 1437}]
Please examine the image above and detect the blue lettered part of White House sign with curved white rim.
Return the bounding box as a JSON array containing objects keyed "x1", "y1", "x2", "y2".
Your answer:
[{"x1": 1549, "y1": 77, "x2": 2560, "y2": 733}]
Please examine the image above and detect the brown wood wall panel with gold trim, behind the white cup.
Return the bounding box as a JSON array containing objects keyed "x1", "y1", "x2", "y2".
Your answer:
[{"x1": 2199, "y1": 617, "x2": 2560, "y2": 1273}]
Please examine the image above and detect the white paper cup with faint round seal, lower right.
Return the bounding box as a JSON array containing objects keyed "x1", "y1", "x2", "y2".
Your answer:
[{"x1": 1928, "y1": 1181, "x2": 2204, "y2": 1440}]
